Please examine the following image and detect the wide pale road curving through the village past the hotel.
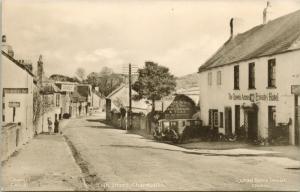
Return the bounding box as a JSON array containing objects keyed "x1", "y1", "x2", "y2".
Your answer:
[{"x1": 64, "y1": 113, "x2": 300, "y2": 191}]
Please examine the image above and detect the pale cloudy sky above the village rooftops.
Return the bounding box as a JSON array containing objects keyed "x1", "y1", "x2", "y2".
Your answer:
[{"x1": 2, "y1": 0, "x2": 300, "y2": 76}]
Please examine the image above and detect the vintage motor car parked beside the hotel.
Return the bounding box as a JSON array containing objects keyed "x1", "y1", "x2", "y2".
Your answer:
[{"x1": 153, "y1": 119, "x2": 201, "y2": 143}]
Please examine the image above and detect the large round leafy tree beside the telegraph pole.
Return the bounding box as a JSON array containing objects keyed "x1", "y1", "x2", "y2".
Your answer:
[{"x1": 132, "y1": 61, "x2": 176, "y2": 112}]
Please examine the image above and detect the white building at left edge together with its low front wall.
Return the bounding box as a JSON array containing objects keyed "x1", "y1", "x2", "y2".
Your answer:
[{"x1": 0, "y1": 36, "x2": 36, "y2": 161}]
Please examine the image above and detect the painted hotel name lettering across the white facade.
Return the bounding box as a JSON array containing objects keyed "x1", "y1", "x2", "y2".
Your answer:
[{"x1": 228, "y1": 92, "x2": 279, "y2": 102}]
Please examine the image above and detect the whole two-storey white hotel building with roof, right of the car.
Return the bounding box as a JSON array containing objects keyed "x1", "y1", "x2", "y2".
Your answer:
[{"x1": 199, "y1": 11, "x2": 300, "y2": 145}]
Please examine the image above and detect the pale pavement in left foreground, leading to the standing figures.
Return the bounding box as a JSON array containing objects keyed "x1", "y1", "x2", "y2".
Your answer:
[{"x1": 1, "y1": 129, "x2": 85, "y2": 191}]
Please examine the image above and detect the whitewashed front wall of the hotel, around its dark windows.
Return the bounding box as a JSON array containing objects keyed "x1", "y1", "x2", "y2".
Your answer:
[{"x1": 199, "y1": 51, "x2": 300, "y2": 144}]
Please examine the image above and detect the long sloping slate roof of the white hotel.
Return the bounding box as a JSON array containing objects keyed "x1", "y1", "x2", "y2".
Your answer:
[{"x1": 199, "y1": 10, "x2": 300, "y2": 72}]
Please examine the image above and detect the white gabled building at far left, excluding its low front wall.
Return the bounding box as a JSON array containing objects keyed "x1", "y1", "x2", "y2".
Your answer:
[{"x1": 1, "y1": 36, "x2": 34, "y2": 143}]
